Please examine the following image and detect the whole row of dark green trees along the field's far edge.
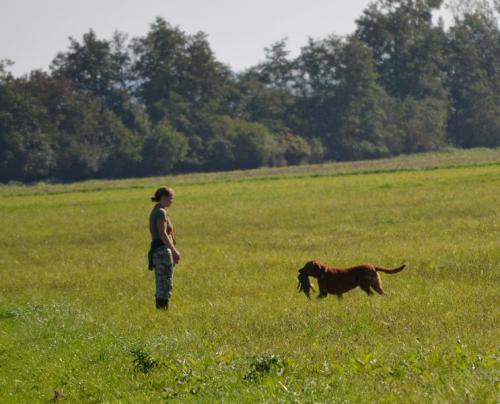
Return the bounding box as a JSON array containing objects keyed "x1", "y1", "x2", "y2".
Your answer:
[{"x1": 0, "y1": 0, "x2": 500, "y2": 182}]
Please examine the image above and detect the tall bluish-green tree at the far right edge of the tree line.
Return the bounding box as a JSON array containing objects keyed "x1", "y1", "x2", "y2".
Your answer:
[{"x1": 447, "y1": 10, "x2": 500, "y2": 147}]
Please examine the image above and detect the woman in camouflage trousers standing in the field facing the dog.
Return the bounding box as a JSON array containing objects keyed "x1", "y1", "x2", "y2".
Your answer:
[{"x1": 148, "y1": 187, "x2": 181, "y2": 309}]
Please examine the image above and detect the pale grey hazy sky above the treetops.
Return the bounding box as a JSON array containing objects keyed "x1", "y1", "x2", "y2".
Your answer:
[{"x1": 0, "y1": 0, "x2": 378, "y2": 76}]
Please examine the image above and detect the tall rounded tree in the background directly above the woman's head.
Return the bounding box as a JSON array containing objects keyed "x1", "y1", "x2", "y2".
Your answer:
[{"x1": 132, "y1": 18, "x2": 229, "y2": 136}]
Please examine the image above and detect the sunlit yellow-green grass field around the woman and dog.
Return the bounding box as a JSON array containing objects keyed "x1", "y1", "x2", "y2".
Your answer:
[{"x1": 0, "y1": 149, "x2": 500, "y2": 403}]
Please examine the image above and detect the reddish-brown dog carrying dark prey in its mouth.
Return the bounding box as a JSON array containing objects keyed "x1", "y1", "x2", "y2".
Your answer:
[{"x1": 298, "y1": 261, "x2": 405, "y2": 298}]
